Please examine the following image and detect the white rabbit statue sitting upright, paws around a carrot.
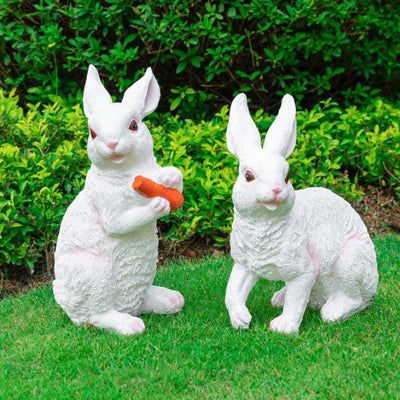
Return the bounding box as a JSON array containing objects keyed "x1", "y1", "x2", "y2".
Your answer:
[{"x1": 53, "y1": 65, "x2": 184, "y2": 335}]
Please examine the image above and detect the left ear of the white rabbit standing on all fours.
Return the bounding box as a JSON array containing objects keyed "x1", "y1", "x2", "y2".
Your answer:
[{"x1": 226, "y1": 93, "x2": 261, "y2": 158}]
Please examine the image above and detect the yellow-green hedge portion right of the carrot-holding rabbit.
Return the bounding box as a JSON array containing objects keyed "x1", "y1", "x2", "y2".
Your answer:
[{"x1": 156, "y1": 99, "x2": 400, "y2": 245}]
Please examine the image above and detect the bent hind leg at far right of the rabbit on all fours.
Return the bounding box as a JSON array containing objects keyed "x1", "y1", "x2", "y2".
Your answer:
[{"x1": 321, "y1": 238, "x2": 378, "y2": 322}]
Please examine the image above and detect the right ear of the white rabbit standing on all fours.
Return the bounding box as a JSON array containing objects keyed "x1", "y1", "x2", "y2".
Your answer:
[{"x1": 264, "y1": 94, "x2": 297, "y2": 158}]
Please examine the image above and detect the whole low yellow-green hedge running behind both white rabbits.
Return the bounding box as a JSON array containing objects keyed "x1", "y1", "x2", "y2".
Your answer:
[{"x1": 0, "y1": 90, "x2": 400, "y2": 270}]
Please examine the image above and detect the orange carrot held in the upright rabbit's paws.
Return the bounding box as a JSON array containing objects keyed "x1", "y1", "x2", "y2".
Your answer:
[{"x1": 132, "y1": 175, "x2": 183, "y2": 211}]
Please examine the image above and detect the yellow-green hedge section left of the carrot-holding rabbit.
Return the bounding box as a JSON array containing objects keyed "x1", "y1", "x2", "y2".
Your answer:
[{"x1": 0, "y1": 90, "x2": 88, "y2": 270}]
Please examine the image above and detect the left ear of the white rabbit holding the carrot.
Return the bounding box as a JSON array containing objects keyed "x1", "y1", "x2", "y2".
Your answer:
[{"x1": 83, "y1": 65, "x2": 112, "y2": 118}]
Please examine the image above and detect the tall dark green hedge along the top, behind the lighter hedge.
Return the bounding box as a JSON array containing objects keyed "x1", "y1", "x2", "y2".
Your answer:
[{"x1": 0, "y1": 0, "x2": 400, "y2": 115}]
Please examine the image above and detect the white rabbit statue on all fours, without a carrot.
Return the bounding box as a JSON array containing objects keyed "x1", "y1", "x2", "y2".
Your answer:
[{"x1": 225, "y1": 93, "x2": 378, "y2": 333}]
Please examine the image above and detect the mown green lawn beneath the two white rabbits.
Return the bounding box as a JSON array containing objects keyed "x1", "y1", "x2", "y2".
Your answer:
[{"x1": 0, "y1": 236, "x2": 400, "y2": 399}]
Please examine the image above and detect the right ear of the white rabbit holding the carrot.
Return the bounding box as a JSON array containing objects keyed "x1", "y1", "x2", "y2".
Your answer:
[{"x1": 122, "y1": 67, "x2": 160, "y2": 118}]
